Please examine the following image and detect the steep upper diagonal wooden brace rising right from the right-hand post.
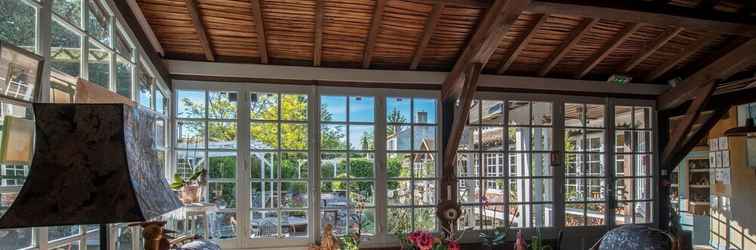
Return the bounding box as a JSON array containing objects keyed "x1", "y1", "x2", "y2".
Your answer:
[{"x1": 661, "y1": 81, "x2": 717, "y2": 169}]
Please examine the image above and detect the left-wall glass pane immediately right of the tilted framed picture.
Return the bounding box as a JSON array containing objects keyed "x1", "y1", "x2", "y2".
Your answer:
[{"x1": 51, "y1": 20, "x2": 81, "y2": 77}]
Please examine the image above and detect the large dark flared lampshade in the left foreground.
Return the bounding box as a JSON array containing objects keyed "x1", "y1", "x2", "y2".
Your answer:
[{"x1": 0, "y1": 104, "x2": 181, "y2": 228}]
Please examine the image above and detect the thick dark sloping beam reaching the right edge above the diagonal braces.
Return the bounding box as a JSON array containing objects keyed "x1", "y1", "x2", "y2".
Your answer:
[{"x1": 657, "y1": 38, "x2": 756, "y2": 110}]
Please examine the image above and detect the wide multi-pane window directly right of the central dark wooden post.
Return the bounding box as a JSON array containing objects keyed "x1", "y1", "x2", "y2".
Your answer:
[{"x1": 457, "y1": 99, "x2": 554, "y2": 229}]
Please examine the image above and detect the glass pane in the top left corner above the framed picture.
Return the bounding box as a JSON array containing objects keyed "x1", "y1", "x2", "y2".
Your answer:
[{"x1": 0, "y1": 0, "x2": 37, "y2": 51}]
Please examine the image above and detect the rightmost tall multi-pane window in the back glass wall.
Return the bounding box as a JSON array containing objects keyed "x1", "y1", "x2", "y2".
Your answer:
[{"x1": 614, "y1": 106, "x2": 654, "y2": 224}]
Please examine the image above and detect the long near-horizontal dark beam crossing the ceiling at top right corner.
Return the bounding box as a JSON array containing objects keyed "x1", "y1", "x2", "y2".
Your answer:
[{"x1": 528, "y1": 0, "x2": 756, "y2": 37}]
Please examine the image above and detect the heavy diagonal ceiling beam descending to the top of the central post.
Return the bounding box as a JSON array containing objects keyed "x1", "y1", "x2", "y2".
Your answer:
[{"x1": 442, "y1": 0, "x2": 530, "y2": 100}]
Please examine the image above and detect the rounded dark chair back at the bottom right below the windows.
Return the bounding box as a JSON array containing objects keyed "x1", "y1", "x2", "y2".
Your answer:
[{"x1": 590, "y1": 225, "x2": 678, "y2": 250}]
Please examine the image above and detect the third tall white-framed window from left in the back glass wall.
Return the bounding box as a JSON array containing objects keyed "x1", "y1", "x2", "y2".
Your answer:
[{"x1": 320, "y1": 96, "x2": 376, "y2": 235}]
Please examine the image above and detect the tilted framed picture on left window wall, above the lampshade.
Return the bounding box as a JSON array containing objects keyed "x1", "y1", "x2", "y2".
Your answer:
[{"x1": 0, "y1": 41, "x2": 44, "y2": 102}]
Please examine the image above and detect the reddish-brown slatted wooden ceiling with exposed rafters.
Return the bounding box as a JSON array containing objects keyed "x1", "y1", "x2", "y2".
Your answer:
[{"x1": 136, "y1": 0, "x2": 756, "y2": 83}]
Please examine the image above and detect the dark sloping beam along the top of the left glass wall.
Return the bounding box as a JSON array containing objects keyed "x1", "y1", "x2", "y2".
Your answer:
[{"x1": 113, "y1": 1, "x2": 173, "y2": 84}]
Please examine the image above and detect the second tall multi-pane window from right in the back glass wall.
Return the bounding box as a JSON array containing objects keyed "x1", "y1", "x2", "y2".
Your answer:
[{"x1": 564, "y1": 103, "x2": 607, "y2": 226}]
